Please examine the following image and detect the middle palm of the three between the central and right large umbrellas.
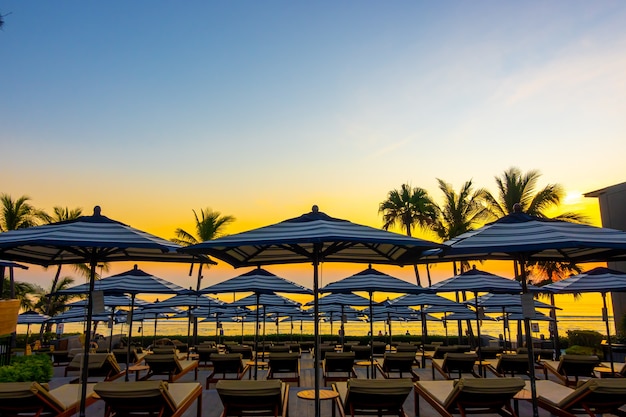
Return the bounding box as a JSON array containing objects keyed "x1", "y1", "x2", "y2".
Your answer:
[{"x1": 432, "y1": 178, "x2": 489, "y2": 275}]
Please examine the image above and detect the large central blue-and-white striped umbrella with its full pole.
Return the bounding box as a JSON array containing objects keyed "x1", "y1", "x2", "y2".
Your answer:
[{"x1": 181, "y1": 206, "x2": 441, "y2": 417}]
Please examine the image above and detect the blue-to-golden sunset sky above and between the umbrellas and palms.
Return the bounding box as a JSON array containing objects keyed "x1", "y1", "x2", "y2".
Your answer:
[{"x1": 0, "y1": 0, "x2": 626, "y2": 292}]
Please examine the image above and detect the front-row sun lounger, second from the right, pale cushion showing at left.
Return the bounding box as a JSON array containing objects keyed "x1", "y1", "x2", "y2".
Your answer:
[{"x1": 415, "y1": 377, "x2": 525, "y2": 417}]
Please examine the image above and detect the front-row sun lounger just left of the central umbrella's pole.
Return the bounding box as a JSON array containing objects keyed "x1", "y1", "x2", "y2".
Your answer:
[{"x1": 215, "y1": 380, "x2": 289, "y2": 417}]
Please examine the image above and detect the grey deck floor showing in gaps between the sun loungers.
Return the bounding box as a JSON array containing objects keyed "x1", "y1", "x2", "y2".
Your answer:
[{"x1": 50, "y1": 352, "x2": 604, "y2": 417}]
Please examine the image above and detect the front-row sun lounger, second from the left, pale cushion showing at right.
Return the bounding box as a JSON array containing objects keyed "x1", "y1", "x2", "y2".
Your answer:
[{"x1": 94, "y1": 381, "x2": 202, "y2": 417}]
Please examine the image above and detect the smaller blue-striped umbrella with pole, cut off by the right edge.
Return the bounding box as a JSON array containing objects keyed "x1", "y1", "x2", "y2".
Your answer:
[{"x1": 542, "y1": 267, "x2": 626, "y2": 373}]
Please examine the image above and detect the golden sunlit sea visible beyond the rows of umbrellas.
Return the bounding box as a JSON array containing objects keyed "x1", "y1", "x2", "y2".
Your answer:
[{"x1": 17, "y1": 293, "x2": 616, "y2": 340}]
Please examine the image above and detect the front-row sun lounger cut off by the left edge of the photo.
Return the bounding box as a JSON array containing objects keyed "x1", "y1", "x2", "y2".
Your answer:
[{"x1": 0, "y1": 382, "x2": 96, "y2": 417}]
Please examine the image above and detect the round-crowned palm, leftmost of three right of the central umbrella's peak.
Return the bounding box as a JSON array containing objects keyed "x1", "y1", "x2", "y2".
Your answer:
[{"x1": 378, "y1": 184, "x2": 437, "y2": 286}]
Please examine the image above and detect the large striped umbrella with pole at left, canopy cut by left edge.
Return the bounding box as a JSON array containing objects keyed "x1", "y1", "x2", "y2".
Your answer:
[{"x1": 0, "y1": 206, "x2": 205, "y2": 417}]
